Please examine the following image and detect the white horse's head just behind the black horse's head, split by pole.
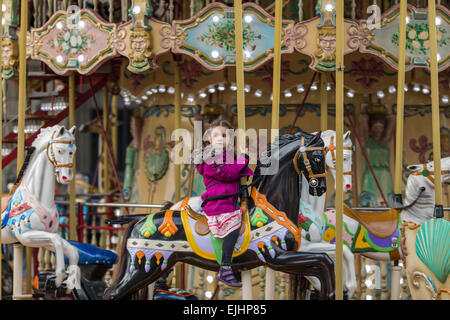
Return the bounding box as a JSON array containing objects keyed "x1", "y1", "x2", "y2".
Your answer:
[{"x1": 322, "y1": 130, "x2": 353, "y2": 192}]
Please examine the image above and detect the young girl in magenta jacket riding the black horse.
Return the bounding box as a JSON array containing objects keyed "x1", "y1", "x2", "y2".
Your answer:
[{"x1": 197, "y1": 120, "x2": 254, "y2": 287}]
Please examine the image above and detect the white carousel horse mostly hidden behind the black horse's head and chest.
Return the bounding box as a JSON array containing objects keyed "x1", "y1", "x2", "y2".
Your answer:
[{"x1": 299, "y1": 130, "x2": 356, "y2": 297}]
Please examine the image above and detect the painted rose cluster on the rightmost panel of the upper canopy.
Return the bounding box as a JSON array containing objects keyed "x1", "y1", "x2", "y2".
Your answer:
[{"x1": 392, "y1": 23, "x2": 447, "y2": 54}]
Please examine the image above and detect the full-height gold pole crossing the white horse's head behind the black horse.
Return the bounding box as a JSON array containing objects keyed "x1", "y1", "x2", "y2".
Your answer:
[{"x1": 335, "y1": 0, "x2": 345, "y2": 300}]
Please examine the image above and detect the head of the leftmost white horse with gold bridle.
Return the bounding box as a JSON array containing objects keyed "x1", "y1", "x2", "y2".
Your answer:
[{"x1": 46, "y1": 126, "x2": 77, "y2": 184}]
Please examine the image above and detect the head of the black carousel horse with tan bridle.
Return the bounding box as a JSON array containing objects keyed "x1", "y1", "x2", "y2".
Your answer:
[{"x1": 293, "y1": 132, "x2": 327, "y2": 196}]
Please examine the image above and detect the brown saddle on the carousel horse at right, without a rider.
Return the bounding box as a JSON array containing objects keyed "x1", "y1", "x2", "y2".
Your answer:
[{"x1": 344, "y1": 203, "x2": 399, "y2": 238}]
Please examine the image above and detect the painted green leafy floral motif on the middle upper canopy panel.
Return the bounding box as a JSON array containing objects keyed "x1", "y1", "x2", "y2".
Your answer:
[{"x1": 198, "y1": 20, "x2": 261, "y2": 52}]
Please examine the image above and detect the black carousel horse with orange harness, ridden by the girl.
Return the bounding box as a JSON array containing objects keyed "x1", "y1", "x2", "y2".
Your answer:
[{"x1": 104, "y1": 131, "x2": 334, "y2": 299}]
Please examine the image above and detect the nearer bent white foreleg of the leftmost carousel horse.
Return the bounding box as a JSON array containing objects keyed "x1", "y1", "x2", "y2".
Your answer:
[{"x1": 16, "y1": 230, "x2": 65, "y2": 287}]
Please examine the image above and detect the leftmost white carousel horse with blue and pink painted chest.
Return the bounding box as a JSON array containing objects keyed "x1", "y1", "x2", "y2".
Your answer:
[{"x1": 2, "y1": 125, "x2": 80, "y2": 292}]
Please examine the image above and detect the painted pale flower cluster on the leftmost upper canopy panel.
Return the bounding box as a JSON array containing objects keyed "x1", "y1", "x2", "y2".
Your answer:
[{"x1": 48, "y1": 29, "x2": 95, "y2": 58}]
